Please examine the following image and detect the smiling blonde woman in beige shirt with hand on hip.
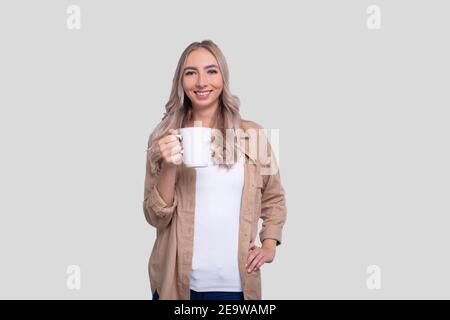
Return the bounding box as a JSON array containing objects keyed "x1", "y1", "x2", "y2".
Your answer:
[{"x1": 143, "y1": 40, "x2": 286, "y2": 300}]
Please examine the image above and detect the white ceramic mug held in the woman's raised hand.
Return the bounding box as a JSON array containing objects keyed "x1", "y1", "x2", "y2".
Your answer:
[{"x1": 176, "y1": 127, "x2": 211, "y2": 168}]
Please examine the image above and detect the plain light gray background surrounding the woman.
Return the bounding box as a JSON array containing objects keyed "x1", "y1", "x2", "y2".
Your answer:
[{"x1": 0, "y1": 0, "x2": 450, "y2": 299}]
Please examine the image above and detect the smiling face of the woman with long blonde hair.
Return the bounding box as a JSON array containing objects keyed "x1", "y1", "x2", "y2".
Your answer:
[{"x1": 182, "y1": 48, "x2": 223, "y2": 110}]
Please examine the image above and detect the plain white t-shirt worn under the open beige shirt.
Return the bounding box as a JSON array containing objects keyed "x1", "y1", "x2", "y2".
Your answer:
[{"x1": 190, "y1": 157, "x2": 244, "y2": 291}]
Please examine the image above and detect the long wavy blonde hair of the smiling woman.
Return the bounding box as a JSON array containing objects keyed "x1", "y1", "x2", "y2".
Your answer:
[{"x1": 148, "y1": 40, "x2": 241, "y2": 174}]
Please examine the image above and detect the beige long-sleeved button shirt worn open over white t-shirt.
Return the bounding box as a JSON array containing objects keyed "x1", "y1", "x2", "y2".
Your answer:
[{"x1": 143, "y1": 120, "x2": 286, "y2": 300}]
